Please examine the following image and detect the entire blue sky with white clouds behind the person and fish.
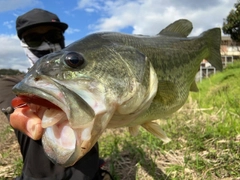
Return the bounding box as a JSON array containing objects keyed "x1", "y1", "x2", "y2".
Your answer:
[{"x1": 0, "y1": 0, "x2": 237, "y2": 71}]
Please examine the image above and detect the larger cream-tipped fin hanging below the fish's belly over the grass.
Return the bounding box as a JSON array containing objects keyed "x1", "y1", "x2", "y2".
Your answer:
[{"x1": 142, "y1": 122, "x2": 171, "y2": 143}]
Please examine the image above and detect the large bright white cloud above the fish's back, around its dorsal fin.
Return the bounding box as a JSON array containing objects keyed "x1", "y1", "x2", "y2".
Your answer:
[{"x1": 78, "y1": 0, "x2": 234, "y2": 35}]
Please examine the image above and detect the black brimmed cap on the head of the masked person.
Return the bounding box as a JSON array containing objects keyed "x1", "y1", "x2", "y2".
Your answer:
[{"x1": 16, "y1": 8, "x2": 68, "y2": 39}]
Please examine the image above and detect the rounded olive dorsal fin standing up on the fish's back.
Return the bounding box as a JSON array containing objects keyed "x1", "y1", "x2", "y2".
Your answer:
[{"x1": 158, "y1": 19, "x2": 193, "y2": 37}]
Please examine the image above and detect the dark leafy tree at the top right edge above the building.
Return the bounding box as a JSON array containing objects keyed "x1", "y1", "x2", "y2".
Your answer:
[{"x1": 222, "y1": 0, "x2": 240, "y2": 42}]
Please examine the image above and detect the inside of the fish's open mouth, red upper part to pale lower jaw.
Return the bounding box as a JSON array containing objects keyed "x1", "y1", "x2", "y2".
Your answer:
[{"x1": 12, "y1": 96, "x2": 77, "y2": 164}]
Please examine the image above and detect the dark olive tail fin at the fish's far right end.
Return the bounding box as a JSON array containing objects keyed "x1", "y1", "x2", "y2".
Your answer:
[{"x1": 202, "y1": 28, "x2": 223, "y2": 71}]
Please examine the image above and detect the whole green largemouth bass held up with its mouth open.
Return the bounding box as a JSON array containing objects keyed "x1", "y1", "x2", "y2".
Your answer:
[{"x1": 13, "y1": 19, "x2": 222, "y2": 167}]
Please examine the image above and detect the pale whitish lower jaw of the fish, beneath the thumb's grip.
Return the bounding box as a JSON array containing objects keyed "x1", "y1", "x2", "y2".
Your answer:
[{"x1": 39, "y1": 109, "x2": 93, "y2": 166}]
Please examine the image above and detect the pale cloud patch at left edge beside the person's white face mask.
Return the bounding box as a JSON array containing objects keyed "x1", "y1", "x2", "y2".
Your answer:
[{"x1": 0, "y1": 34, "x2": 30, "y2": 71}]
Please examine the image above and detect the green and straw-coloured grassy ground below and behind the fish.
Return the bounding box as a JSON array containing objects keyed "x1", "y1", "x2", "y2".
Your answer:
[{"x1": 0, "y1": 63, "x2": 240, "y2": 180}]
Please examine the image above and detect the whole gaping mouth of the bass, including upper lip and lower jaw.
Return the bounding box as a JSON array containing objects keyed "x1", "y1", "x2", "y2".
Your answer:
[{"x1": 13, "y1": 78, "x2": 96, "y2": 167}]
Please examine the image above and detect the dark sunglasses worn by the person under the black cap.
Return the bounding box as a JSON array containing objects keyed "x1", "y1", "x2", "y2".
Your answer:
[{"x1": 23, "y1": 29, "x2": 64, "y2": 47}]
